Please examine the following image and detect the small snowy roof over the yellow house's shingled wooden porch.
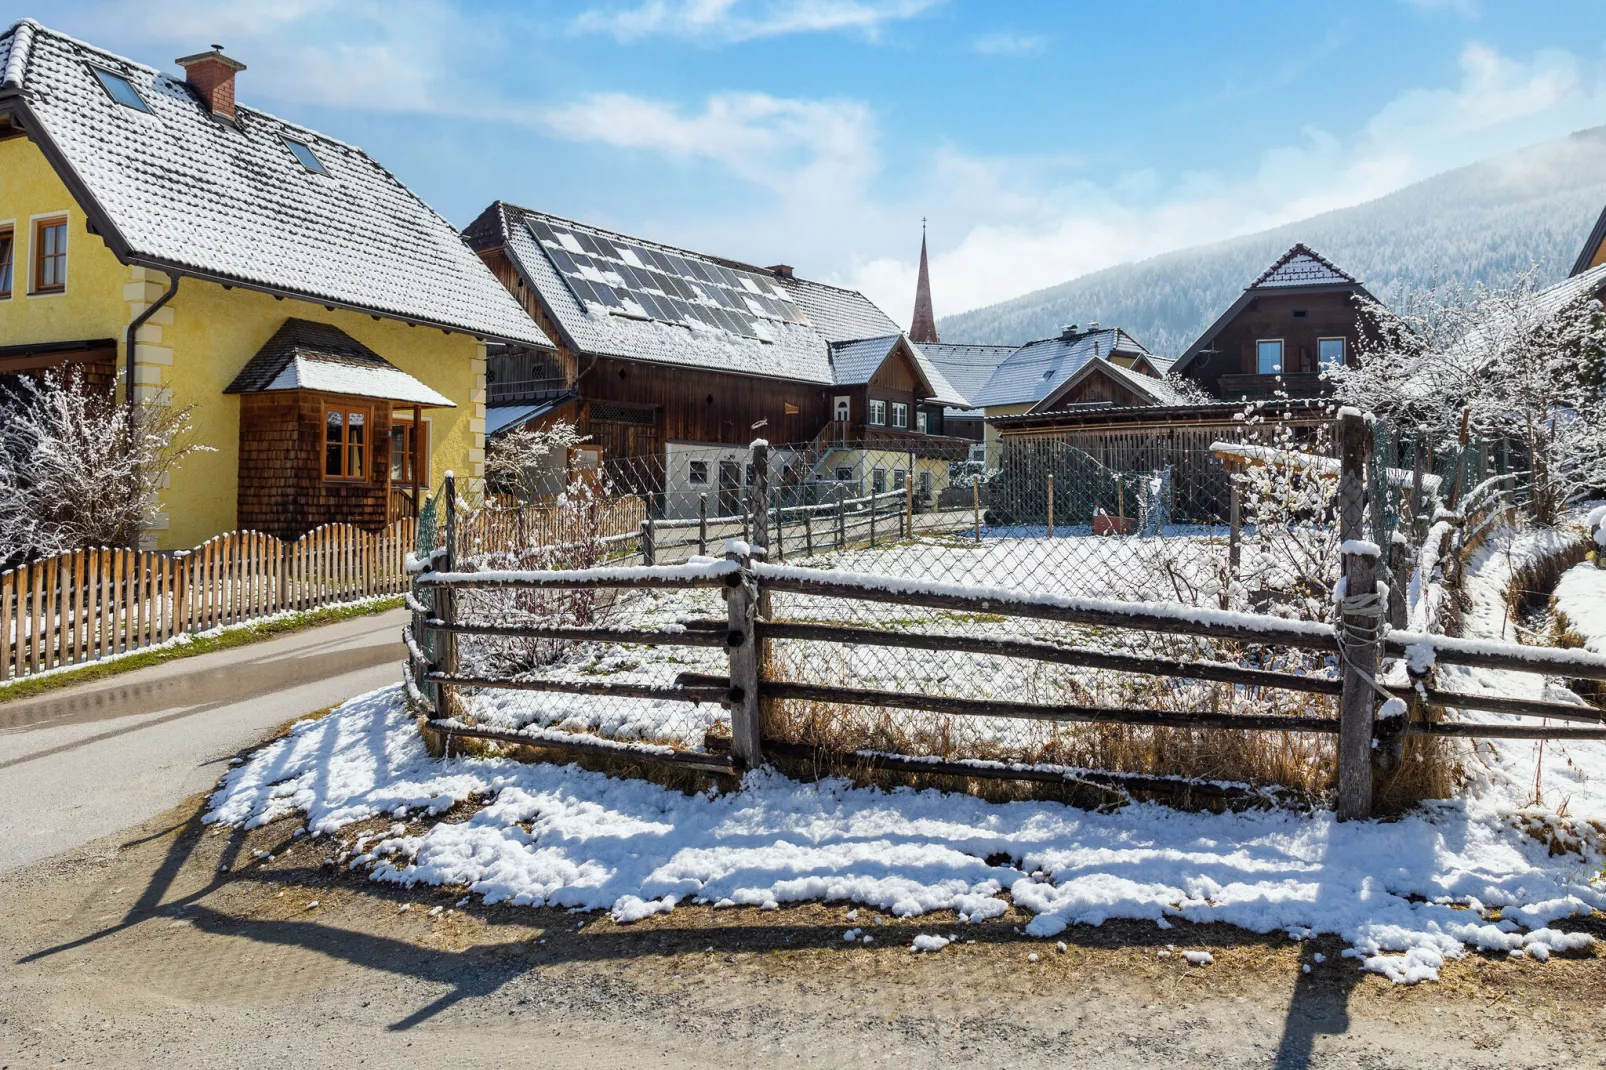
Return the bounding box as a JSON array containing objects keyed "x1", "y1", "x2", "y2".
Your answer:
[{"x1": 223, "y1": 318, "x2": 456, "y2": 408}]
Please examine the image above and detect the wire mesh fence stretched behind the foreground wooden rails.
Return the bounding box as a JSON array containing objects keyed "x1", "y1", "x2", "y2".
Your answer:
[{"x1": 421, "y1": 420, "x2": 1516, "y2": 794}]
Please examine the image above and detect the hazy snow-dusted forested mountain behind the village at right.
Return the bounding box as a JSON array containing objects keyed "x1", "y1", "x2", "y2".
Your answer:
[{"x1": 938, "y1": 127, "x2": 1606, "y2": 357}]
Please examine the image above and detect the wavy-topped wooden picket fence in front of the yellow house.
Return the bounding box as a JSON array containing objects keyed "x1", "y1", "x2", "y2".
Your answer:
[{"x1": 0, "y1": 519, "x2": 418, "y2": 681}]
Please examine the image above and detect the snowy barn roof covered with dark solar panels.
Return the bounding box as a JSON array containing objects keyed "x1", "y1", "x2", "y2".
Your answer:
[{"x1": 464, "y1": 201, "x2": 898, "y2": 384}]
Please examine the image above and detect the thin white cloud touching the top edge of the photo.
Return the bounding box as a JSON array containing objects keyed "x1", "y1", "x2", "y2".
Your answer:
[{"x1": 572, "y1": 0, "x2": 940, "y2": 43}]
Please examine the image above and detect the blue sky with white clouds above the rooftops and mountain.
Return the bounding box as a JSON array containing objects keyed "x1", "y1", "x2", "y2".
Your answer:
[{"x1": 12, "y1": 0, "x2": 1606, "y2": 321}]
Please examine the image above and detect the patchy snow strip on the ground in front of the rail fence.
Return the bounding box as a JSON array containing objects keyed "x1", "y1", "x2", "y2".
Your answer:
[{"x1": 207, "y1": 688, "x2": 1606, "y2": 982}]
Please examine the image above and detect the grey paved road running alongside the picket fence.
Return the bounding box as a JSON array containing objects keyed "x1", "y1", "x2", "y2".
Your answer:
[{"x1": 0, "y1": 609, "x2": 406, "y2": 872}]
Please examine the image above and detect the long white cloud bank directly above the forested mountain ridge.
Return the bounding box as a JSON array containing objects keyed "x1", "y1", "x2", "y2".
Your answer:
[{"x1": 843, "y1": 43, "x2": 1606, "y2": 317}]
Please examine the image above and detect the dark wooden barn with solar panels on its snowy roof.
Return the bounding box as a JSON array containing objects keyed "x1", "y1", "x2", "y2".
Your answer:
[{"x1": 464, "y1": 201, "x2": 965, "y2": 516}]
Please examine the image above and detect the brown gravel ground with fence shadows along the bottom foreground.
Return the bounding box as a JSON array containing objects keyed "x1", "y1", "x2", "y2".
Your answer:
[{"x1": 0, "y1": 774, "x2": 1606, "y2": 1070}]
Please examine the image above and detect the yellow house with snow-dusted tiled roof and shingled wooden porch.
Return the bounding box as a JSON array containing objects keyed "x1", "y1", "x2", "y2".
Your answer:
[{"x1": 0, "y1": 19, "x2": 552, "y2": 549}]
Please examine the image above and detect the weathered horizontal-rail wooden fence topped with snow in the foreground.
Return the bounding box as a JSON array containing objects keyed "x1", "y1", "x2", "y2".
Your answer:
[{"x1": 406, "y1": 440, "x2": 1606, "y2": 816}]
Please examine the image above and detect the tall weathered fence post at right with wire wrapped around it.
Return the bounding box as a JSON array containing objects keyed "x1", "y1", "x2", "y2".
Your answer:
[{"x1": 1336, "y1": 408, "x2": 1383, "y2": 821}]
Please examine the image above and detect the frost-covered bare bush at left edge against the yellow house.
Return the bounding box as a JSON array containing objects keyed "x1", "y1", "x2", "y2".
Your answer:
[{"x1": 0, "y1": 370, "x2": 212, "y2": 561}]
